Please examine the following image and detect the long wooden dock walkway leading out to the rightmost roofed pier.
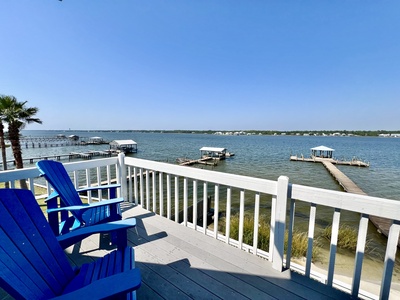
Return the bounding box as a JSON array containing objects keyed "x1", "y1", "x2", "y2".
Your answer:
[{"x1": 321, "y1": 160, "x2": 400, "y2": 247}]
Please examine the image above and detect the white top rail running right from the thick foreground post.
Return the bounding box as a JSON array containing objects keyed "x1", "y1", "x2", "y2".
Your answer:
[{"x1": 289, "y1": 184, "x2": 400, "y2": 220}]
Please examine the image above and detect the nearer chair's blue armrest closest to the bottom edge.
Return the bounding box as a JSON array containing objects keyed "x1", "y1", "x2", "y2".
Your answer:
[{"x1": 54, "y1": 268, "x2": 141, "y2": 300}]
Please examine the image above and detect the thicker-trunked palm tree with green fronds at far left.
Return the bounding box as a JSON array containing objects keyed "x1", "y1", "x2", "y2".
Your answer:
[{"x1": 2, "y1": 96, "x2": 42, "y2": 188}]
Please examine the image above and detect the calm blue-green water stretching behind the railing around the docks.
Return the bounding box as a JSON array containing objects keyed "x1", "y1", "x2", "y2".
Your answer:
[{"x1": 16, "y1": 130, "x2": 400, "y2": 200}]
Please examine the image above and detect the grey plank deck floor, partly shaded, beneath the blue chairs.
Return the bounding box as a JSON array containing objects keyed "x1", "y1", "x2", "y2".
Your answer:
[{"x1": 62, "y1": 205, "x2": 350, "y2": 299}]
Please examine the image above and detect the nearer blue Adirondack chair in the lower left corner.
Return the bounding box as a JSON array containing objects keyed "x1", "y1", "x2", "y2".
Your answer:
[{"x1": 0, "y1": 189, "x2": 141, "y2": 299}]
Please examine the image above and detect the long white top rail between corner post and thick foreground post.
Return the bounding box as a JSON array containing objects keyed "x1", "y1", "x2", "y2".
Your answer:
[{"x1": 125, "y1": 157, "x2": 277, "y2": 195}]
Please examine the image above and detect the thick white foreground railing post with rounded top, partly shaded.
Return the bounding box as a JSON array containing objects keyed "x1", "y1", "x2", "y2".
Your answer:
[{"x1": 272, "y1": 176, "x2": 289, "y2": 272}]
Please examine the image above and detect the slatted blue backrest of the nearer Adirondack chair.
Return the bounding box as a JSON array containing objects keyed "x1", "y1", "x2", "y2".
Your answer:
[{"x1": 0, "y1": 189, "x2": 74, "y2": 299}]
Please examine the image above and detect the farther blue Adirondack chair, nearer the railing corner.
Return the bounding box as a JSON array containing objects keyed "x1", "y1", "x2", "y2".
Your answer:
[{"x1": 36, "y1": 160, "x2": 123, "y2": 235}]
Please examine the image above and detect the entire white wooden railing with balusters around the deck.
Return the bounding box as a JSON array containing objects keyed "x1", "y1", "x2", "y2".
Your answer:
[{"x1": 0, "y1": 154, "x2": 400, "y2": 299}]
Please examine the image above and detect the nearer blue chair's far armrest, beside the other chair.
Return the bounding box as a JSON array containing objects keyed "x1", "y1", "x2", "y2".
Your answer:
[{"x1": 57, "y1": 218, "x2": 136, "y2": 249}]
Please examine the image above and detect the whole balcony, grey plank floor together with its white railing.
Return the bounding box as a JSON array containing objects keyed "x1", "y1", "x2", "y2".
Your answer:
[{"x1": 0, "y1": 154, "x2": 400, "y2": 299}]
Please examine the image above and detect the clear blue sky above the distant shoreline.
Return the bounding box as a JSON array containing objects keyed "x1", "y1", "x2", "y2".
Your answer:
[{"x1": 0, "y1": 0, "x2": 400, "y2": 131}]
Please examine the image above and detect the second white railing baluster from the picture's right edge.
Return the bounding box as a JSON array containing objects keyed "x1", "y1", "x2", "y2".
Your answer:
[{"x1": 351, "y1": 214, "x2": 369, "y2": 298}]
